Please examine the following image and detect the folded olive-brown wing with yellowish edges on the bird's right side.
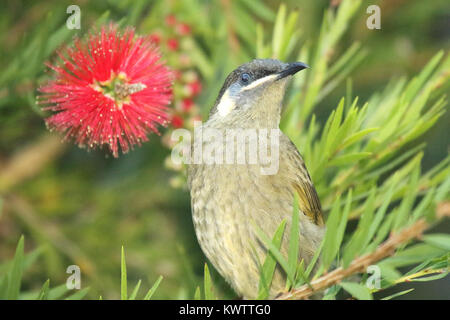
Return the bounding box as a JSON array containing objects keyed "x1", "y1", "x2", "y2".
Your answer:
[{"x1": 288, "y1": 138, "x2": 324, "y2": 226}]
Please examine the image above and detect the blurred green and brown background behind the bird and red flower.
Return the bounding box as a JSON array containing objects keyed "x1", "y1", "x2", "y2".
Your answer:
[{"x1": 0, "y1": 0, "x2": 450, "y2": 299}]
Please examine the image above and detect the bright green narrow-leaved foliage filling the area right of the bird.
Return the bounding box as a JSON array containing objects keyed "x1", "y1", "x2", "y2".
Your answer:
[{"x1": 250, "y1": 1, "x2": 450, "y2": 299}]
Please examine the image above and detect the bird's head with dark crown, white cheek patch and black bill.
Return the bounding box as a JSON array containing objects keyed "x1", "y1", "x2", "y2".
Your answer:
[{"x1": 209, "y1": 59, "x2": 308, "y2": 127}]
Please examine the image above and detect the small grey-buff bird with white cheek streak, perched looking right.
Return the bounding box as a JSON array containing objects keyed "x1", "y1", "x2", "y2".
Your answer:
[{"x1": 188, "y1": 59, "x2": 325, "y2": 299}]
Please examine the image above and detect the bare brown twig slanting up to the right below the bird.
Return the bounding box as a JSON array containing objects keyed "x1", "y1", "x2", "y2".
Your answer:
[{"x1": 277, "y1": 202, "x2": 450, "y2": 300}]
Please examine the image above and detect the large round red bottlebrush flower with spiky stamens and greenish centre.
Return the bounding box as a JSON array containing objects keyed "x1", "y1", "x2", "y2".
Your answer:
[{"x1": 38, "y1": 25, "x2": 173, "y2": 157}]
